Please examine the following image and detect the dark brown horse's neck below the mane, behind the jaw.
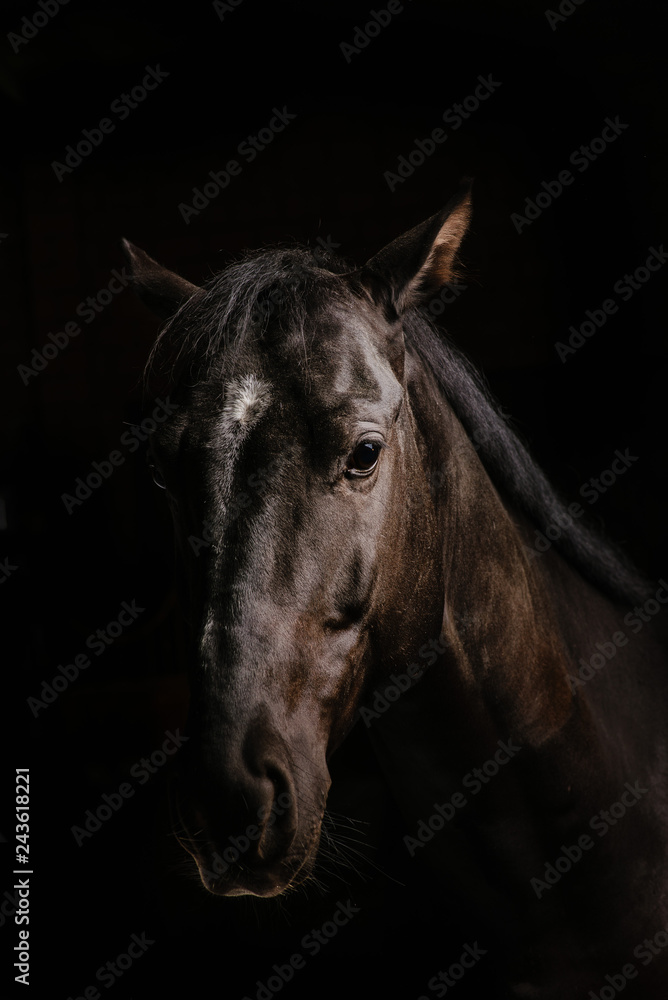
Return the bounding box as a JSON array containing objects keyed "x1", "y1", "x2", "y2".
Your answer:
[{"x1": 367, "y1": 360, "x2": 667, "y2": 960}]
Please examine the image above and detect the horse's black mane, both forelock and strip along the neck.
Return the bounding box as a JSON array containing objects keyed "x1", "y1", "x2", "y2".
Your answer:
[{"x1": 147, "y1": 246, "x2": 648, "y2": 603}]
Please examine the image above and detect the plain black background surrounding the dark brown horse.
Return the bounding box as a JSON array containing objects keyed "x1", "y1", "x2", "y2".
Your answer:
[{"x1": 0, "y1": 0, "x2": 668, "y2": 1000}]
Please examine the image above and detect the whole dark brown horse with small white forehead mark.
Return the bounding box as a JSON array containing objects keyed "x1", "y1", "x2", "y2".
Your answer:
[{"x1": 123, "y1": 183, "x2": 668, "y2": 1000}]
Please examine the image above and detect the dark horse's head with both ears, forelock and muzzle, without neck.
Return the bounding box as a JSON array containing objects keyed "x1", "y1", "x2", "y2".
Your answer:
[{"x1": 125, "y1": 187, "x2": 470, "y2": 896}]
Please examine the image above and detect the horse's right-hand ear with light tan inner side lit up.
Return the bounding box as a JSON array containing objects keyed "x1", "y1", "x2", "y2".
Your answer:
[{"x1": 358, "y1": 181, "x2": 471, "y2": 314}]
